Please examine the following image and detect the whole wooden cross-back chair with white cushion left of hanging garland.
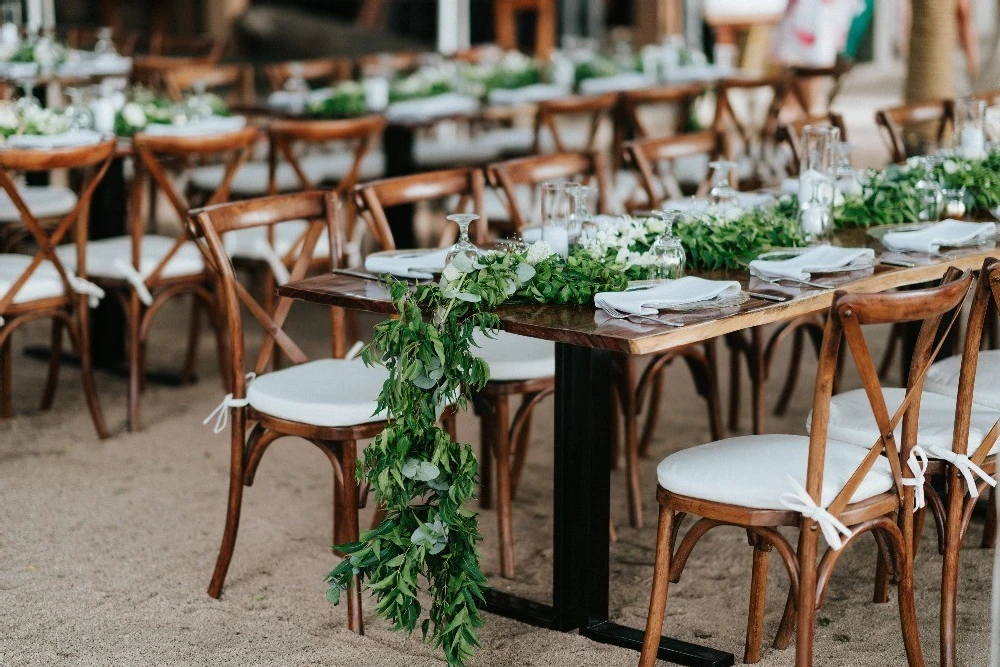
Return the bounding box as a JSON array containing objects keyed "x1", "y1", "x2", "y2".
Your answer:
[{"x1": 187, "y1": 191, "x2": 388, "y2": 634}]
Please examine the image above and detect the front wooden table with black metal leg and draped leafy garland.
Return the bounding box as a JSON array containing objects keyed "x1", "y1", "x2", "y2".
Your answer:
[{"x1": 278, "y1": 230, "x2": 997, "y2": 667}]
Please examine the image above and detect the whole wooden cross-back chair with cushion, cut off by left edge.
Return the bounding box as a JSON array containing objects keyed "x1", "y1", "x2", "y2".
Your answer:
[{"x1": 0, "y1": 141, "x2": 115, "y2": 438}]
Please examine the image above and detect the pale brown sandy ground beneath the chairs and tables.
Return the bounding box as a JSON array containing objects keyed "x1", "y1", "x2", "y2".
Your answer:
[{"x1": 0, "y1": 64, "x2": 993, "y2": 667}]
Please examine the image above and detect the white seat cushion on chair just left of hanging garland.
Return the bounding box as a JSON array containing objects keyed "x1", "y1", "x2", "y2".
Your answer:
[{"x1": 247, "y1": 359, "x2": 389, "y2": 426}]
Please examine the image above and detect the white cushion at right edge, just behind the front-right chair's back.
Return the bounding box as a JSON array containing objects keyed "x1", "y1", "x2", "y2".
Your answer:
[{"x1": 807, "y1": 388, "x2": 1000, "y2": 452}]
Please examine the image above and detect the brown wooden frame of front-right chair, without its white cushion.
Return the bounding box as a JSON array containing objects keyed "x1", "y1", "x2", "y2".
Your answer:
[{"x1": 639, "y1": 270, "x2": 972, "y2": 667}]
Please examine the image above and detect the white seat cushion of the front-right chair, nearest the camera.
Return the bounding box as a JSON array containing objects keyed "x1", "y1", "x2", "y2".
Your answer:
[{"x1": 656, "y1": 435, "x2": 893, "y2": 510}]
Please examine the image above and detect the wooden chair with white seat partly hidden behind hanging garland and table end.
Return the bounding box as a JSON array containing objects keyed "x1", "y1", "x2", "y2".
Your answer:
[{"x1": 355, "y1": 169, "x2": 555, "y2": 578}]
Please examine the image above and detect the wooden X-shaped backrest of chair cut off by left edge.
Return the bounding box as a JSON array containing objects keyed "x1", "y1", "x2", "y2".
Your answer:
[{"x1": 0, "y1": 141, "x2": 115, "y2": 316}]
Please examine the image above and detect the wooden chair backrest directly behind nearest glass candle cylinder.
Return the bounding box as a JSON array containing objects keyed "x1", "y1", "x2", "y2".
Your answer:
[{"x1": 486, "y1": 151, "x2": 610, "y2": 233}]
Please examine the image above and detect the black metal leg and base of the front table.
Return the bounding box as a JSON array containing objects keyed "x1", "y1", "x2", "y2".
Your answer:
[{"x1": 486, "y1": 343, "x2": 735, "y2": 667}]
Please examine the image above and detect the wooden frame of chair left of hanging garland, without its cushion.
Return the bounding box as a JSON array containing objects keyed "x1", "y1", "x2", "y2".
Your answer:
[{"x1": 187, "y1": 191, "x2": 385, "y2": 634}]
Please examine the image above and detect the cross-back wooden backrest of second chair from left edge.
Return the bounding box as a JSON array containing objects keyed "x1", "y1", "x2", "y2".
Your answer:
[{"x1": 129, "y1": 127, "x2": 260, "y2": 287}]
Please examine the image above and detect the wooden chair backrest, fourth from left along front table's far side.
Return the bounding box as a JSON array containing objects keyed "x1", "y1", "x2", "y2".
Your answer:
[{"x1": 624, "y1": 130, "x2": 736, "y2": 207}]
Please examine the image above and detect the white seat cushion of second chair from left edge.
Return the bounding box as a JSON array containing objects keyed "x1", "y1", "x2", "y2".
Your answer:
[{"x1": 56, "y1": 234, "x2": 205, "y2": 280}]
